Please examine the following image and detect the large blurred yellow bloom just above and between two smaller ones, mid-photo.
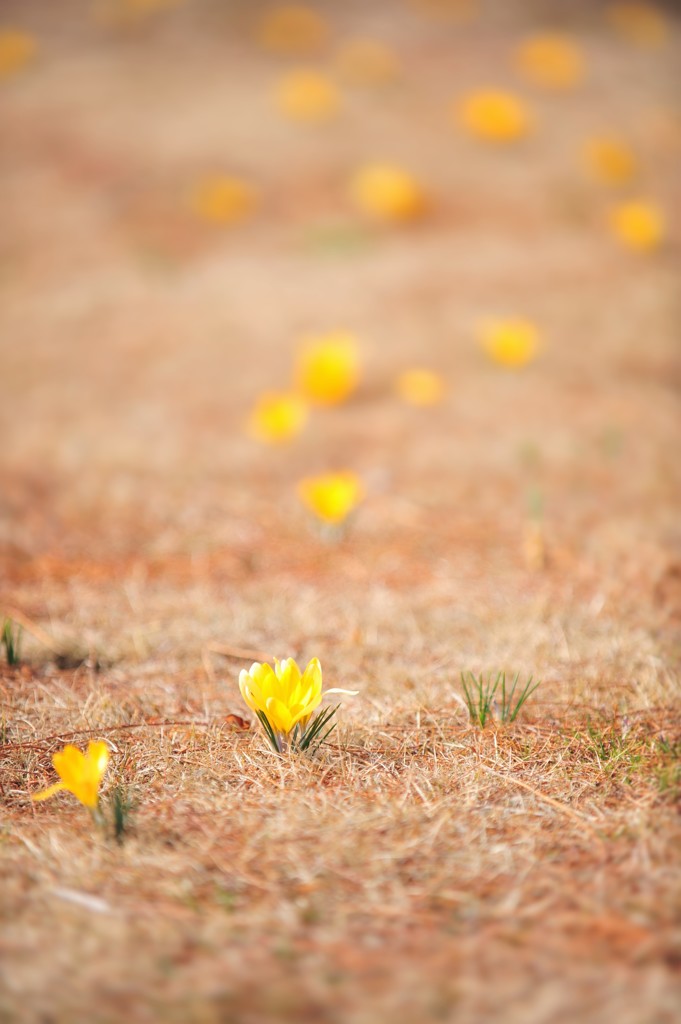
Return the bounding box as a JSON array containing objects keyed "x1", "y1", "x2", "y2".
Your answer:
[{"x1": 295, "y1": 331, "x2": 359, "y2": 406}]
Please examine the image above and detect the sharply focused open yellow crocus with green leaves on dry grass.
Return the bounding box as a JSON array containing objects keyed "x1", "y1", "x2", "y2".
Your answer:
[{"x1": 239, "y1": 657, "x2": 357, "y2": 753}]
